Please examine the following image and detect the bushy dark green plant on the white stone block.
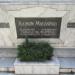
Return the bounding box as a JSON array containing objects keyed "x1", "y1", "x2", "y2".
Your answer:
[{"x1": 17, "y1": 38, "x2": 53, "y2": 61}]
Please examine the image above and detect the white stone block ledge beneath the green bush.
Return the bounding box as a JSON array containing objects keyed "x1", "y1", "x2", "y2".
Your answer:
[{"x1": 14, "y1": 58, "x2": 60, "y2": 74}]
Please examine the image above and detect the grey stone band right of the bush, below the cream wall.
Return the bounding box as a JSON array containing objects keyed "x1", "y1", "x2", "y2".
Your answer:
[{"x1": 54, "y1": 47, "x2": 75, "y2": 57}]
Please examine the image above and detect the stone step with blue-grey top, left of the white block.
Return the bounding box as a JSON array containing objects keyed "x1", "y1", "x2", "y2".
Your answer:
[{"x1": 0, "y1": 57, "x2": 15, "y2": 72}]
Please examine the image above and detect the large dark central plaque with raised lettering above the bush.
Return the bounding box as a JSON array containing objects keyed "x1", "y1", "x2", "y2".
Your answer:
[{"x1": 15, "y1": 18, "x2": 61, "y2": 38}]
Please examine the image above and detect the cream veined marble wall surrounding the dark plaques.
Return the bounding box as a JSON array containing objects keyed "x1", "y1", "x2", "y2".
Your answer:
[{"x1": 0, "y1": 5, "x2": 75, "y2": 48}]
